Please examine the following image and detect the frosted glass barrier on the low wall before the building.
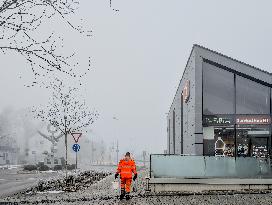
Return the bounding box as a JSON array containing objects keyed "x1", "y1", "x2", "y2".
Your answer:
[{"x1": 150, "y1": 154, "x2": 272, "y2": 178}]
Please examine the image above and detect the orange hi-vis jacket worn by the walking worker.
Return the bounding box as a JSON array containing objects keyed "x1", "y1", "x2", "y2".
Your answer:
[{"x1": 117, "y1": 159, "x2": 137, "y2": 179}]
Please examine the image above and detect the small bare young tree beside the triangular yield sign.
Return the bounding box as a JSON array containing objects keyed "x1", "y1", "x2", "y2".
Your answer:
[{"x1": 32, "y1": 78, "x2": 98, "y2": 177}]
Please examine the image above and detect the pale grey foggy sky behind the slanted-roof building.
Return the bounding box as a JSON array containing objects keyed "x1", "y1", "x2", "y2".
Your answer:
[{"x1": 0, "y1": 0, "x2": 272, "y2": 156}]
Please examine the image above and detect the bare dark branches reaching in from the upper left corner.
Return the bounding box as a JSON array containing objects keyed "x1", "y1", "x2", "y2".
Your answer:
[{"x1": 0, "y1": 0, "x2": 91, "y2": 81}]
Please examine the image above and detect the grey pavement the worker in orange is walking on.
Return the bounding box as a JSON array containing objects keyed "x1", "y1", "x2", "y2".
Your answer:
[{"x1": 0, "y1": 171, "x2": 272, "y2": 205}]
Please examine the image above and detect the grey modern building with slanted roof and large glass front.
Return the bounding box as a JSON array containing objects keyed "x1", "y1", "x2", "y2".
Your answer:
[{"x1": 167, "y1": 45, "x2": 272, "y2": 158}]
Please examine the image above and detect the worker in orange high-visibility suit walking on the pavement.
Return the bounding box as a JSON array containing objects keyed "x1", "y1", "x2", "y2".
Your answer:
[{"x1": 115, "y1": 152, "x2": 137, "y2": 200}]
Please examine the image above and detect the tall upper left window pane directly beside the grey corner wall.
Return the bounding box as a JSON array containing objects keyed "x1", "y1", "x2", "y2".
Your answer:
[{"x1": 203, "y1": 62, "x2": 234, "y2": 115}]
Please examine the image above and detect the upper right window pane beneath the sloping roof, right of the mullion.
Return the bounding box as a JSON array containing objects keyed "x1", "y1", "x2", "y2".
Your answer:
[{"x1": 236, "y1": 75, "x2": 270, "y2": 114}]
